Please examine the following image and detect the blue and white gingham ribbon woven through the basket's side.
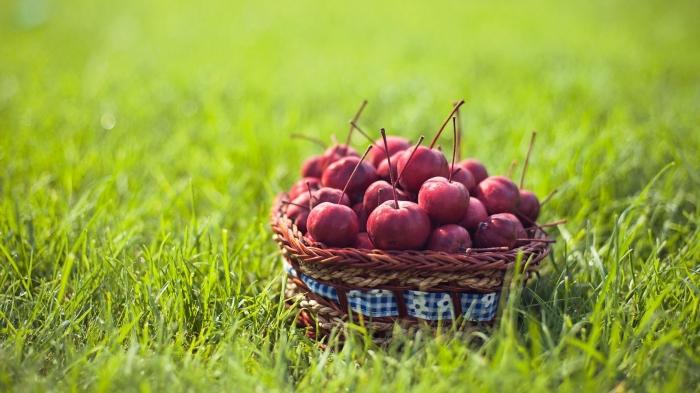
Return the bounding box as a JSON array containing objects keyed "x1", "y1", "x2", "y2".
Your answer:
[{"x1": 283, "y1": 260, "x2": 499, "y2": 321}]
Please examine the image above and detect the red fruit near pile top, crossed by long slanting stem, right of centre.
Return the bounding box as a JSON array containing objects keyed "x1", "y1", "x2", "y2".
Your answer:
[{"x1": 396, "y1": 146, "x2": 450, "y2": 192}]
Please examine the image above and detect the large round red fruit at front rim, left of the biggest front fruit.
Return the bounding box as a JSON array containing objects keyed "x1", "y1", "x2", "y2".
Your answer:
[{"x1": 307, "y1": 202, "x2": 360, "y2": 247}]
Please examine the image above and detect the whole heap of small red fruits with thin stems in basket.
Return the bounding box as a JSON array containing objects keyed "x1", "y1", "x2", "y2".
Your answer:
[{"x1": 283, "y1": 101, "x2": 540, "y2": 253}]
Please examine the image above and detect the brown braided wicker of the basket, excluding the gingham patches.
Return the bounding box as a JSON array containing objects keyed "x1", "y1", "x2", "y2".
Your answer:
[{"x1": 270, "y1": 194, "x2": 550, "y2": 333}]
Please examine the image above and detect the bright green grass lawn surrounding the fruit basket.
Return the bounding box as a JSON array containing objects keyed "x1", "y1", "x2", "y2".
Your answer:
[{"x1": 0, "y1": 0, "x2": 700, "y2": 392}]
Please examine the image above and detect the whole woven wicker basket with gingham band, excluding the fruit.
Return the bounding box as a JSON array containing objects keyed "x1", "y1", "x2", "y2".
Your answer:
[{"x1": 270, "y1": 195, "x2": 550, "y2": 338}]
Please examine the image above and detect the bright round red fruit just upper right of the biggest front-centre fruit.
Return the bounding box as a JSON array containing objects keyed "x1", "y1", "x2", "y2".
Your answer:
[{"x1": 418, "y1": 177, "x2": 469, "y2": 224}]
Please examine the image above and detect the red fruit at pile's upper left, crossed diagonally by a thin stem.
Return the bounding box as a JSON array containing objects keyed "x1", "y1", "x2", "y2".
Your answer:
[{"x1": 321, "y1": 157, "x2": 377, "y2": 195}]
